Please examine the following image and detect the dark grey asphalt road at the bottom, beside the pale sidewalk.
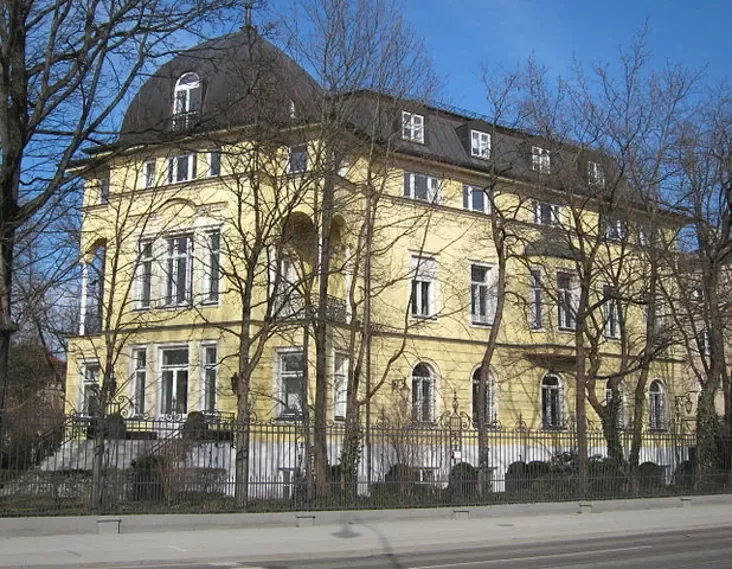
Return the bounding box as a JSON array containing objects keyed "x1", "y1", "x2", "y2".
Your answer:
[{"x1": 96, "y1": 526, "x2": 732, "y2": 569}]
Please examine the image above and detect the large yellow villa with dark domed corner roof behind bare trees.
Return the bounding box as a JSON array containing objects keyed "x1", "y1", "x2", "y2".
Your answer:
[{"x1": 67, "y1": 31, "x2": 688, "y2": 450}]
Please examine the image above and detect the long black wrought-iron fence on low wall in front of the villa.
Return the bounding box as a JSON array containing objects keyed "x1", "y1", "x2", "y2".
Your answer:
[{"x1": 0, "y1": 413, "x2": 730, "y2": 516}]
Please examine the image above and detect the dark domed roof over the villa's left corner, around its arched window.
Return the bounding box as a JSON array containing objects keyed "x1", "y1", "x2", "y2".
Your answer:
[{"x1": 119, "y1": 28, "x2": 322, "y2": 145}]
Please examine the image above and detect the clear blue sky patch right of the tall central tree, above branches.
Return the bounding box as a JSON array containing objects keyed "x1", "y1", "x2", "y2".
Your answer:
[{"x1": 402, "y1": 0, "x2": 732, "y2": 112}]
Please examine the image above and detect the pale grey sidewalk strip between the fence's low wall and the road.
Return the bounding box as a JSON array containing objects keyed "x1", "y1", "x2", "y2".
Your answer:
[{"x1": 0, "y1": 497, "x2": 732, "y2": 568}]
